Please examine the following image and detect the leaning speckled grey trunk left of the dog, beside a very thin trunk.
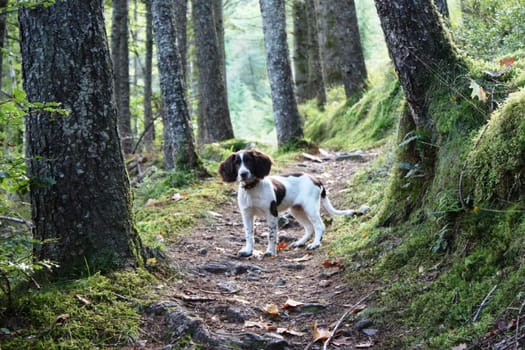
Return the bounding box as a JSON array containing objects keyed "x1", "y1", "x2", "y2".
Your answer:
[{"x1": 152, "y1": 0, "x2": 202, "y2": 170}]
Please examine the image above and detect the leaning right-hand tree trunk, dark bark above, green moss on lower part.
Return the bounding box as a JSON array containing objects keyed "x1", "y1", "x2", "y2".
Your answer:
[{"x1": 375, "y1": 0, "x2": 465, "y2": 224}]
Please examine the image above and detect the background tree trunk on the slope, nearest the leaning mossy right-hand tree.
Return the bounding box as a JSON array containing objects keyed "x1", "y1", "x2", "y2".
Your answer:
[{"x1": 334, "y1": 0, "x2": 367, "y2": 97}]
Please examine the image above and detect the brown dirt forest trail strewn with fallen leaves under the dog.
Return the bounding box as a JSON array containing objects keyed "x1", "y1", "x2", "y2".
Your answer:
[{"x1": 143, "y1": 151, "x2": 380, "y2": 349}]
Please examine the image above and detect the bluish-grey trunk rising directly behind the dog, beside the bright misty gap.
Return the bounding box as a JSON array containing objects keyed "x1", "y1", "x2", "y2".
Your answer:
[{"x1": 259, "y1": 0, "x2": 303, "y2": 146}]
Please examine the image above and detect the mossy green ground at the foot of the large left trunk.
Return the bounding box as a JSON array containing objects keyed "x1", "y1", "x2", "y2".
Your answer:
[{"x1": 0, "y1": 270, "x2": 154, "y2": 350}]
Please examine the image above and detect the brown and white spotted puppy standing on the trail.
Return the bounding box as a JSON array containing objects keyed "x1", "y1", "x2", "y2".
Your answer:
[{"x1": 219, "y1": 150, "x2": 368, "y2": 256}]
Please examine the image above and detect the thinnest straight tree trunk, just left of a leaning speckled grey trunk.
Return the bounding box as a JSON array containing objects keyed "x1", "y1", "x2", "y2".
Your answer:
[{"x1": 144, "y1": 0, "x2": 155, "y2": 152}]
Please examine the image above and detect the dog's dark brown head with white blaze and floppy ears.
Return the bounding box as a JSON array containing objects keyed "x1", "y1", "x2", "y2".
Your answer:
[{"x1": 219, "y1": 150, "x2": 272, "y2": 183}]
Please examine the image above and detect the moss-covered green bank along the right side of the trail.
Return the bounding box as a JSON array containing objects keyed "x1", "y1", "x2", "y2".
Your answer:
[{"x1": 308, "y1": 64, "x2": 525, "y2": 349}]
